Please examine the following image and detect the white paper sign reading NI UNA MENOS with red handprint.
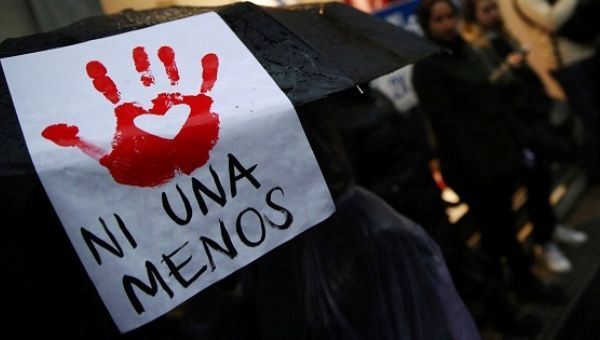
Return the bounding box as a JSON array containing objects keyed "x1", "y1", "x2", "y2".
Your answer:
[{"x1": 2, "y1": 13, "x2": 334, "y2": 332}]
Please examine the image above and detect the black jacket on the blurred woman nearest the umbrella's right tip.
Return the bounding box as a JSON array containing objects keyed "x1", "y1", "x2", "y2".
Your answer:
[{"x1": 413, "y1": 38, "x2": 519, "y2": 193}]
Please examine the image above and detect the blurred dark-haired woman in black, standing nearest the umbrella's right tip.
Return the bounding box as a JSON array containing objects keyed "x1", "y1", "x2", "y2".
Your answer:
[{"x1": 413, "y1": 0, "x2": 564, "y2": 333}]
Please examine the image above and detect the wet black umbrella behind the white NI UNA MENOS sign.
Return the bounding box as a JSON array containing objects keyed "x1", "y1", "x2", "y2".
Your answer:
[{"x1": 0, "y1": 3, "x2": 436, "y2": 177}]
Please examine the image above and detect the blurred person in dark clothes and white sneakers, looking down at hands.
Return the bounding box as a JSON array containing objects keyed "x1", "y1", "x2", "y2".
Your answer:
[{"x1": 461, "y1": 0, "x2": 587, "y2": 273}]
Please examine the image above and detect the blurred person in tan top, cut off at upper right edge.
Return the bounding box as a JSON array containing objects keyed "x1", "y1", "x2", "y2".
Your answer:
[{"x1": 498, "y1": 0, "x2": 600, "y2": 181}]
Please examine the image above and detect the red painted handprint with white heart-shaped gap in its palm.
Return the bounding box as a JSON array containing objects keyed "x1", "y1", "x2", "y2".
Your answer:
[{"x1": 42, "y1": 46, "x2": 219, "y2": 187}]
